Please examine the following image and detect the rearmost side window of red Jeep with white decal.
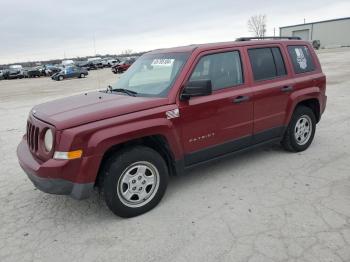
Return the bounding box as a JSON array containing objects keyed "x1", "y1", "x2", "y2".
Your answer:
[{"x1": 288, "y1": 46, "x2": 315, "y2": 74}]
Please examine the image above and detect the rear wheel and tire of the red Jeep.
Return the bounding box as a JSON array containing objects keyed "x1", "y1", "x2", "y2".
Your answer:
[{"x1": 281, "y1": 106, "x2": 316, "y2": 152}]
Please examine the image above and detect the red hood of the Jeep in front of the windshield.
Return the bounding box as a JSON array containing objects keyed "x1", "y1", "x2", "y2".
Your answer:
[{"x1": 32, "y1": 92, "x2": 168, "y2": 130}]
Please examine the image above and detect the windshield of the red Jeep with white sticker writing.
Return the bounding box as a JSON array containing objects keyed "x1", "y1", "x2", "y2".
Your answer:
[{"x1": 113, "y1": 53, "x2": 189, "y2": 97}]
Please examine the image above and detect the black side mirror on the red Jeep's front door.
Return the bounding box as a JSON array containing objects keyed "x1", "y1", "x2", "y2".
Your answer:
[{"x1": 180, "y1": 80, "x2": 212, "y2": 100}]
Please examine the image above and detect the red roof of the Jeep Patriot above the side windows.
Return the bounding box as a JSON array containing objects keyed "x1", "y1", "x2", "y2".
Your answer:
[{"x1": 148, "y1": 39, "x2": 302, "y2": 54}]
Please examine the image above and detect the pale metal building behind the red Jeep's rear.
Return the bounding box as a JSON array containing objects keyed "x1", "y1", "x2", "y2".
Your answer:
[{"x1": 280, "y1": 17, "x2": 350, "y2": 48}]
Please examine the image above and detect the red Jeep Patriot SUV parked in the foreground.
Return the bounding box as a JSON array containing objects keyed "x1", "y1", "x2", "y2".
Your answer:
[{"x1": 17, "y1": 37, "x2": 326, "y2": 217}]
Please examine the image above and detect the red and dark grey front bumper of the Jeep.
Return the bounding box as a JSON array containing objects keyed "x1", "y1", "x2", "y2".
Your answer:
[{"x1": 17, "y1": 140, "x2": 94, "y2": 199}]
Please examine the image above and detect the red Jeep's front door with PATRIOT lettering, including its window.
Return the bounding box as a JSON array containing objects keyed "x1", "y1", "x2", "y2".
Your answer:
[{"x1": 179, "y1": 48, "x2": 253, "y2": 166}]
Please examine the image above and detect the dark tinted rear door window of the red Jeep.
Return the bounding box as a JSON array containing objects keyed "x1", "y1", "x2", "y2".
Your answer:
[{"x1": 248, "y1": 47, "x2": 287, "y2": 81}]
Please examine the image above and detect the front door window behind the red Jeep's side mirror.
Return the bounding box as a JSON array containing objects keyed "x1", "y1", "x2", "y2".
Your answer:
[{"x1": 190, "y1": 51, "x2": 243, "y2": 90}]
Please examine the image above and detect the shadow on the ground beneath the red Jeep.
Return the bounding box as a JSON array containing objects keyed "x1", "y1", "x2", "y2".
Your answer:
[{"x1": 29, "y1": 141, "x2": 285, "y2": 223}]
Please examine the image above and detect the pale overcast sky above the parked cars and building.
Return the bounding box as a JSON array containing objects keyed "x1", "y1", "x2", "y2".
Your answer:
[{"x1": 0, "y1": 0, "x2": 350, "y2": 64}]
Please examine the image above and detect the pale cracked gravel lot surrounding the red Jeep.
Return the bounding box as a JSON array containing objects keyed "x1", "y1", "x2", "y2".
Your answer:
[{"x1": 0, "y1": 48, "x2": 350, "y2": 262}]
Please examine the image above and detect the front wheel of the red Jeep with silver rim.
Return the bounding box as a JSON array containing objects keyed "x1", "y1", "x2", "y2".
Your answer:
[{"x1": 100, "y1": 146, "x2": 169, "y2": 218}]
